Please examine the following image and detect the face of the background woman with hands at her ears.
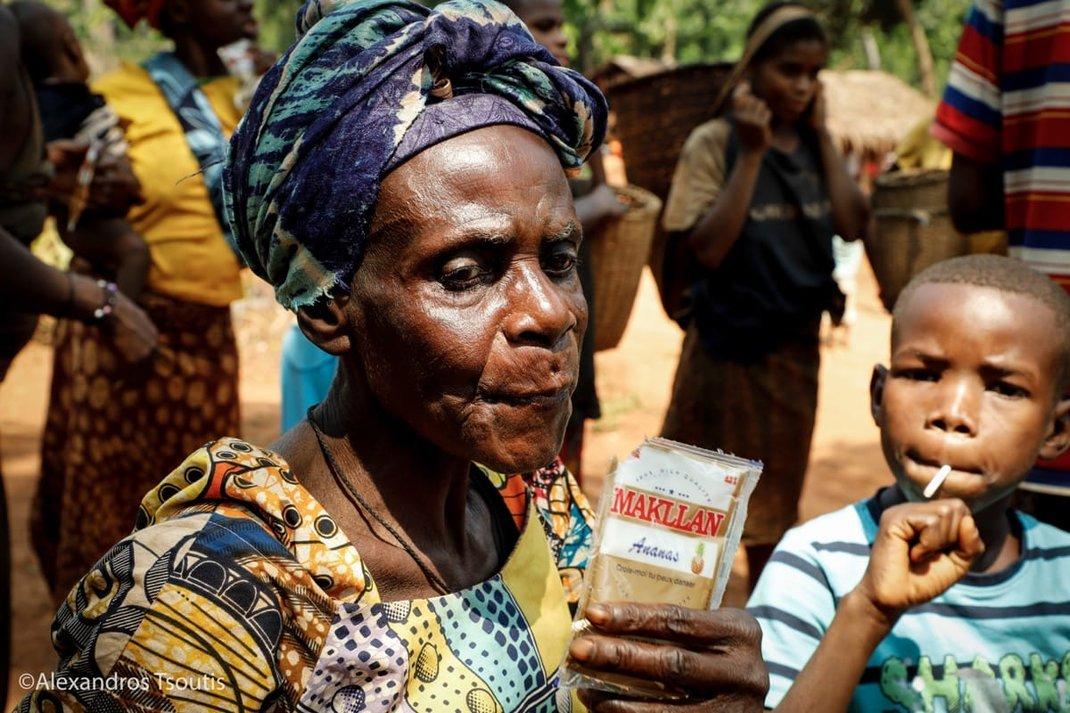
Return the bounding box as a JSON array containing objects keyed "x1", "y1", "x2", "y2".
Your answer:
[{"x1": 751, "y1": 40, "x2": 828, "y2": 124}]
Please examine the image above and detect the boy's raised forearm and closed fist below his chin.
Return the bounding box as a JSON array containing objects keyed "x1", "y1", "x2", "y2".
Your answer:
[{"x1": 775, "y1": 500, "x2": 984, "y2": 713}]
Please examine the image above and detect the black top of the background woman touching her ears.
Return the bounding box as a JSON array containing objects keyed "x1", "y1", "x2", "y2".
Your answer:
[{"x1": 692, "y1": 127, "x2": 843, "y2": 362}]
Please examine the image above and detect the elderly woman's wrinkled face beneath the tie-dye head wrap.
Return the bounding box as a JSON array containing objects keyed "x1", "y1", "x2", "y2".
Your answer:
[{"x1": 347, "y1": 126, "x2": 587, "y2": 472}]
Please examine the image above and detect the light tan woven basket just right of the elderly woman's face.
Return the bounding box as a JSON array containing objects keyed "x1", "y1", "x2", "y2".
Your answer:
[{"x1": 591, "y1": 185, "x2": 661, "y2": 351}]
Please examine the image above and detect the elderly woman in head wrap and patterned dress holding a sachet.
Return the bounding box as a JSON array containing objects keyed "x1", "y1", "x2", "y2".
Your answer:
[{"x1": 20, "y1": 0, "x2": 766, "y2": 713}]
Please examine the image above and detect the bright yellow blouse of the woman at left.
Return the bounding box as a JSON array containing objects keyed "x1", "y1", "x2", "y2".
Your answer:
[{"x1": 94, "y1": 63, "x2": 242, "y2": 306}]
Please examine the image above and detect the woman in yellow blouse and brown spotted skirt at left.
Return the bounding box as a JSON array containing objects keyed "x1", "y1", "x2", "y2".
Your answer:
[{"x1": 31, "y1": 0, "x2": 257, "y2": 601}]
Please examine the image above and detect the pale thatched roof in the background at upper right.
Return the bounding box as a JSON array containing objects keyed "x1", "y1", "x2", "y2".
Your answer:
[{"x1": 821, "y1": 70, "x2": 935, "y2": 156}]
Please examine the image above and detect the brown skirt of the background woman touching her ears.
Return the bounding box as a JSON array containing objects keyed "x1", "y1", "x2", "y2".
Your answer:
[{"x1": 661, "y1": 324, "x2": 821, "y2": 545}]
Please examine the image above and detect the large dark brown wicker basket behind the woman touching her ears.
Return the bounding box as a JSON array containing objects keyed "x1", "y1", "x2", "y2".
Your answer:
[{"x1": 607, "y1": 63, "x2": 732, "y2": 315}]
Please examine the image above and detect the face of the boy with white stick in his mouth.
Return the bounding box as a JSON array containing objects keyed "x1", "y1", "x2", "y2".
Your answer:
[{"x1": 872, "y1": 284, "x2": 1070, "y2": 512}]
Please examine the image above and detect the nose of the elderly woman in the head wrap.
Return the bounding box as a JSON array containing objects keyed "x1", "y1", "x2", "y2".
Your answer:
[{"x1": 505, "y1": 261, "x2": 586, "y2": 349}]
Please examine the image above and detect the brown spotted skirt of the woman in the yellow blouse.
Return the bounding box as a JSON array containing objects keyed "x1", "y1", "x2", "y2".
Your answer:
[{"x1": 30, "y1": 293, "x2": 241, "y2": 602}]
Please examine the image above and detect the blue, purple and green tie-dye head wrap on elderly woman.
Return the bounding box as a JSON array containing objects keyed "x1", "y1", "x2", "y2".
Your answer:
[{"x1": 224, "y1": 0, "x2": 607, "y2": 309}]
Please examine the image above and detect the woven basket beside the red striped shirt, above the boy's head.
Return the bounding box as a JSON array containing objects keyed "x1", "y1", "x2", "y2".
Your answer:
[{"x1": 866, "y1": 169, "x2": 969, "y2": 312}]
